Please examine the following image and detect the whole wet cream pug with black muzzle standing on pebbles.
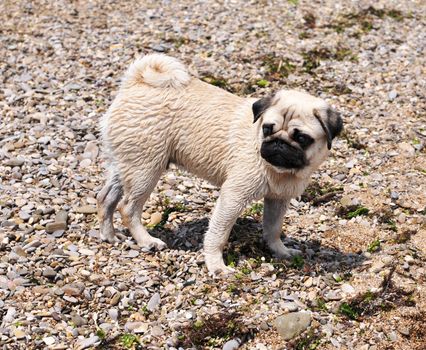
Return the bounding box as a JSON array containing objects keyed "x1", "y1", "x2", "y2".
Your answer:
[{"x1": 97, "y1": 54, "x2": 343, "y2": 273}]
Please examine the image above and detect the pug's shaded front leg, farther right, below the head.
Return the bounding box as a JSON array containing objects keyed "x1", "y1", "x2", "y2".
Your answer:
[{"x1": 263, "y1": 198, "x2": 301, "y2": 259}]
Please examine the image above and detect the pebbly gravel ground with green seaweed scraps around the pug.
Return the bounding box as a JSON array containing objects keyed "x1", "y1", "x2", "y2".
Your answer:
[{"x1": 0, "y1": 0, "x2": 426, "y2": 350}]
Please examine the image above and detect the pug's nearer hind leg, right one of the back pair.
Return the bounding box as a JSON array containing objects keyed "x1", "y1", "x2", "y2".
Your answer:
[{"x1": 119, "y1": 166, "x2": 166, "y2": 250}]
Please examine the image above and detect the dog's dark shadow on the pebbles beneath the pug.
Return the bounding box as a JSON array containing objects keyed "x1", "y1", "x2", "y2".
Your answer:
[{"x1": 151, "y1": 218, "x2": 366, "y2": 274}]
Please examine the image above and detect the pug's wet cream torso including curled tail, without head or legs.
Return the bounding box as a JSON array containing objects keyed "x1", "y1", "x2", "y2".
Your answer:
[{"x1": 101, "y1": 54, "x2": 252, "y2": 185}]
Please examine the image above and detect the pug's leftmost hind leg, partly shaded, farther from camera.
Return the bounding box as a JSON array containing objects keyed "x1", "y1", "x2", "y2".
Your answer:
[{"x1": 96, "y1": 173, "x2": 123, "y2": 243}]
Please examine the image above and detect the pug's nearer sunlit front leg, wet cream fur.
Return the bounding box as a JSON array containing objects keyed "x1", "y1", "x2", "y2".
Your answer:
[{"x1": 204, "y1": 184, "x2": 250, "y2": 274}]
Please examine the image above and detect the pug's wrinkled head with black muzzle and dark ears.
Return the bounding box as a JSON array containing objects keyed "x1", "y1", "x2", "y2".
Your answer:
[{"x1": 252, "y1": 90, "x2": 343, "y2": 174}]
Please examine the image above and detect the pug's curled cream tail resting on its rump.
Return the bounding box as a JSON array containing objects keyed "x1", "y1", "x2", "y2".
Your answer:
[{"x1": 123, "y1": 54, "x2": 191, "y2": 88}]
